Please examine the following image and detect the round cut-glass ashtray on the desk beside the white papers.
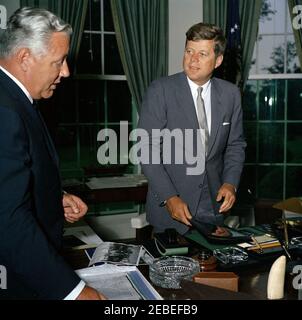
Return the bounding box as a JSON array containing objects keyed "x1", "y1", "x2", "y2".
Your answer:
[{"x1": 149, "y1": 256, "x2": 200, "y2": 289}]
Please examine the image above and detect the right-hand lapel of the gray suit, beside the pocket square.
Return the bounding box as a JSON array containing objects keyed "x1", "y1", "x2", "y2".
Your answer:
[{"x1": 208, "y1": 78, "x2": 223, "y2": 157}]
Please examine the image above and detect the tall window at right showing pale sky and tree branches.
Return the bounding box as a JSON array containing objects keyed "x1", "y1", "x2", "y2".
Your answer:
[{"x1": 242, "y1": 0, "x2": 302, "y2": 199}]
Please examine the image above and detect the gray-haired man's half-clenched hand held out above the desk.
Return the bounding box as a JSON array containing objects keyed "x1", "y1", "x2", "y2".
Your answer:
[{"x1": 63, "y1": 193, "x2": 88, "y2": 223}]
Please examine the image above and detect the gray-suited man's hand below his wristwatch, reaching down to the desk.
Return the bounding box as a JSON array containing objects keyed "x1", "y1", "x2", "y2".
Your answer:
[{"x1": 166, "y1": 196, "x2": 192, "y2": 226}]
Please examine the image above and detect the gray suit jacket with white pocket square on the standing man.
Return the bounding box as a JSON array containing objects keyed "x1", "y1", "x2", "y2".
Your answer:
[{"x1": 138, "y1": 72, "x2": 246, "y2": 233}]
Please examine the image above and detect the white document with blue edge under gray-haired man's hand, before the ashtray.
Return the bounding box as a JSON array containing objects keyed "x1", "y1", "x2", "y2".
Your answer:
[{"x1": 76, "y1": 264, "x2": 162, "y2": 300}]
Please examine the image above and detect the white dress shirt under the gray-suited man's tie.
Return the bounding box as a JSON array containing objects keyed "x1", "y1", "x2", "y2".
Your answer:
[{"x1": 187, "y1": 77, "x2": 212, "y2": 135}]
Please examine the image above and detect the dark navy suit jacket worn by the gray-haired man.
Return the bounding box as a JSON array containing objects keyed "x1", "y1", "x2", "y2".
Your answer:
[{"x1": 0, "y1": 70, "x2": 80, "y2": 299}]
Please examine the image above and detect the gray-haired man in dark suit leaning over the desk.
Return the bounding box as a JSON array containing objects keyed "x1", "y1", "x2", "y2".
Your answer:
[{"x1": 0, "y1": 8, "x2": 104, "y2": 300}]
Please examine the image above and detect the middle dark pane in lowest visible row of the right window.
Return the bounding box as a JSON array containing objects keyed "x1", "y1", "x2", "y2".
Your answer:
[{"x1": 258, "y1": 166, "x2": 283, "y2": 199}]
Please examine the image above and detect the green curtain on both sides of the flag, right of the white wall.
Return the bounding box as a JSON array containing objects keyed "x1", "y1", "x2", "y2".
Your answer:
[{"x1": 203, "y1": 0, "x2": 262, "y2": 87}]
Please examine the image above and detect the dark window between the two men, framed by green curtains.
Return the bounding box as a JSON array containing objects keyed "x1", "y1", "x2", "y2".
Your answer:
[{"x1": 56, "y1": 0, "x2": 136, "y2": 214}]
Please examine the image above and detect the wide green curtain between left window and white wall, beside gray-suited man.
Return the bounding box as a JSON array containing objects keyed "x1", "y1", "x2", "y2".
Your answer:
[{"x1": 111, "y1": 0, "x2": 169, "y2": 108}]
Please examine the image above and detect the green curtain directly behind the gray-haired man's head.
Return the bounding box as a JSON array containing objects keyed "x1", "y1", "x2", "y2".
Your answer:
[{"x1": 20, "y1": 0, "x2": 88, "y2": 72}]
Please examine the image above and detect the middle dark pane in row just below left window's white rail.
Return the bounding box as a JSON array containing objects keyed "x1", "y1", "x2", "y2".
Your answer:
[{"x1": 79, "y1": 80, "x2": 105, "y2": 123}]
